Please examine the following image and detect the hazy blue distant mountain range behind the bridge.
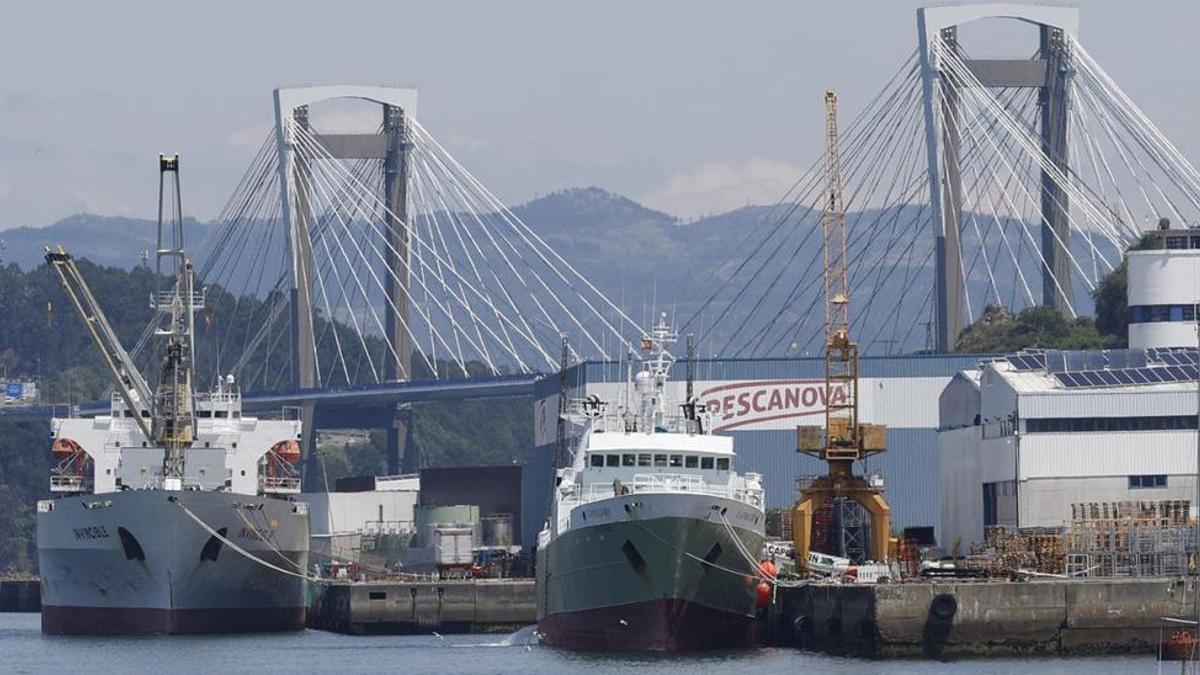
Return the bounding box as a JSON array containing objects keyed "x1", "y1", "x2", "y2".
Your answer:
[{"x1": 0, "y1": 187, "x2": 1120, "y2": 354}]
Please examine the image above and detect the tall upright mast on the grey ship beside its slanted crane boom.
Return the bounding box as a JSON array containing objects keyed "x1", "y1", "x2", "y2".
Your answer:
[{"x1": 151, "y1": 155, "x2": 204, "y2": 489}]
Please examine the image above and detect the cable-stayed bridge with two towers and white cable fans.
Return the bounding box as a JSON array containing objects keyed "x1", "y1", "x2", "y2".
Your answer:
[{"x1": 4, "y1": 4, "x2": 1200, "y2": 484}]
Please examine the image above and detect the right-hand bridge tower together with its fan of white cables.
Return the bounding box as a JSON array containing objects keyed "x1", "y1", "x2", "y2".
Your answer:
[{"x1": 684, "y1": 2, "x2": 1200, "y2": 357}]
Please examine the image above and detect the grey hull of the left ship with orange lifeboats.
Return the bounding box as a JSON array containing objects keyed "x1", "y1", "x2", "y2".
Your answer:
[{"x1": 37, "y1": 490, "x2": 308, "y2": 634}]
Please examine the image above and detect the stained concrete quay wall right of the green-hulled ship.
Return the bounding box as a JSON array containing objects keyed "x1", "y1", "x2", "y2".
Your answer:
[{"x1": 763, "y1": 579, "x2": 1195, "y2": 658}]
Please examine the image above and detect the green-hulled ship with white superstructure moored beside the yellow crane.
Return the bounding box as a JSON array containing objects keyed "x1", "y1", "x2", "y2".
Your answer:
[{"x1": 536, "y1": 317, "x2": 766, "y2": 652}]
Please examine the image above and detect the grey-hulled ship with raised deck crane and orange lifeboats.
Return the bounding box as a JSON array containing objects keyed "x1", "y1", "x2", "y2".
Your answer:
[{"x1": 37, "y1": 157, "x2": 308, "y2": 634}]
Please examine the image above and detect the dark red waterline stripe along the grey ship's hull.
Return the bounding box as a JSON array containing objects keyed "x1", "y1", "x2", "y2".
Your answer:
[{"x1": 42, "y1": 605, "x2": 305, "y2": 635}]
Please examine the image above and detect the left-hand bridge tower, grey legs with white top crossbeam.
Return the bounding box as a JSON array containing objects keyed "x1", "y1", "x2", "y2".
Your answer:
[{"x1": 275, "y1": 85, "x2": 416, "y2": 485}]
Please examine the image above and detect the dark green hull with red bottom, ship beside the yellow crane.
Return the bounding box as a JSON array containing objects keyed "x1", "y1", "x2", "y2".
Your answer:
[{"x1": 538, "y1": 494, "x2": 763, "y2": 652}]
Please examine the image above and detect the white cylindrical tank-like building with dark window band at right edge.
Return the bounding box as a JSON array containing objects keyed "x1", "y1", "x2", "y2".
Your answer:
[{"x1": 1128, "y1": 243, "x2": 1200, "y2": 348}]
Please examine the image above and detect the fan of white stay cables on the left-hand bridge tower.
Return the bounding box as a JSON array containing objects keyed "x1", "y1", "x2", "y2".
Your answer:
[{"x1": 187, "y1": 108, "x2": 642, "y2": 389}]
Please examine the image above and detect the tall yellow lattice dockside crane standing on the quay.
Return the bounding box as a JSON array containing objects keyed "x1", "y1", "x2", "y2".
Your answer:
[{"x1": 792, "y1": 90, "x2": 892, "y2": 568}]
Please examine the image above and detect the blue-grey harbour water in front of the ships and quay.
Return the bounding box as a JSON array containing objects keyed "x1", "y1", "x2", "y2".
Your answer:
[{"x1": 0, "y1": 614, "x2": 1158, "y2": 675}]
